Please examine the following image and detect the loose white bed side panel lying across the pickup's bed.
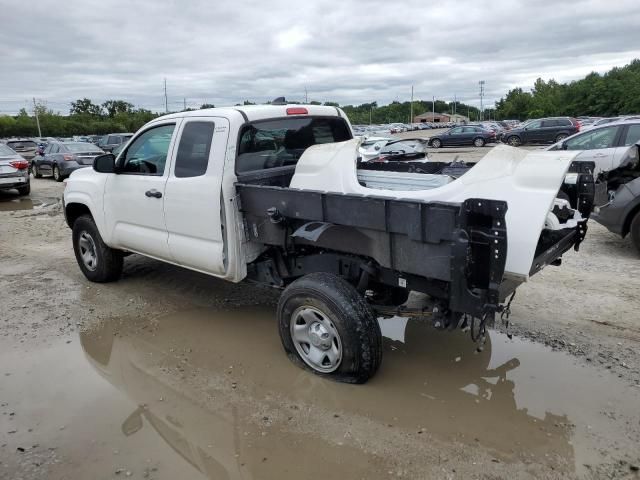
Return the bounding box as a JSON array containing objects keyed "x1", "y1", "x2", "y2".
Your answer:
[{"x1": 290, "y1": 140, "x2": 579, "y2": 280}]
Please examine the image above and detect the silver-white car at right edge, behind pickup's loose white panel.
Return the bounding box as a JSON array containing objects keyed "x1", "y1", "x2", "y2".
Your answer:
[{"x1": 547, "y1": 120, "x2": 640, "y2": 175}]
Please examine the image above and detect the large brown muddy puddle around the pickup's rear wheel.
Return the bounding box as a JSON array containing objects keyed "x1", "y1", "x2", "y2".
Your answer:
[{"x1": 0, "y1": 309, "x2": 640, "y2": 479}]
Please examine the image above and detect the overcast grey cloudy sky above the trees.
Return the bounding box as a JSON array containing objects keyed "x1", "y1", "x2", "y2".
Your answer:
[{"x1": 0, "y1": 0, "x2": 640, "y2": 113}]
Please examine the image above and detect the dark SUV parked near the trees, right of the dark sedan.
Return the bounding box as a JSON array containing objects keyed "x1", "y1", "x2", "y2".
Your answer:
[{"x1": 500, "y1": 117, "x2": 580, "y2": 147}]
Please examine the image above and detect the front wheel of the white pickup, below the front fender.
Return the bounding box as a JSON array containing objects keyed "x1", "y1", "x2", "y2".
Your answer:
[{"x1": 71, "y1": 215, "x2": 123, "y2": 283}]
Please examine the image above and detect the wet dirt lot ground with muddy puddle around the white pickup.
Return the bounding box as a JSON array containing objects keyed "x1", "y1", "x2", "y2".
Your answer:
[{"x1": 0, "y1": 158, "x2": 640, "y2": 479}]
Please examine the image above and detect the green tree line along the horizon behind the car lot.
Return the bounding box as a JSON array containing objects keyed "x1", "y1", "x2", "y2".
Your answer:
[{"x1": 0, "y1": 59, "x2": 640, "y2": 137}]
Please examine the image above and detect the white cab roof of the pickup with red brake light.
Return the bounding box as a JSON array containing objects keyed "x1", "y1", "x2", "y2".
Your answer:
[{"x1": 155, "y1": 104, "x2": 347, "y2": 122}]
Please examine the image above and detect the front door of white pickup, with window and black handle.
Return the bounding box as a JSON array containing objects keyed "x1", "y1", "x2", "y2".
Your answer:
[{"x1": 104, "y1": 121, "x2": 179, "y2": 261}]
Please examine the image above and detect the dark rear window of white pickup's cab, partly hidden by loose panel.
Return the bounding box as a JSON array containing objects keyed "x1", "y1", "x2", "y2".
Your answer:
[{"x1": 236, "y1": 117, "x2": 352, "y2": 172}]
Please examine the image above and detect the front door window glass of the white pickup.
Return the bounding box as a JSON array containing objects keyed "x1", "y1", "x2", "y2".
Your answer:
[{"x1": 120, "y1": 124, "x2": 175, "y2": 176}]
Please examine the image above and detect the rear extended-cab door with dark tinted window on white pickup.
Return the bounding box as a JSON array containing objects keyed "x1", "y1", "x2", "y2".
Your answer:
[{"x1": 164, "y1": 117, "x2": 229, "y2": 275}]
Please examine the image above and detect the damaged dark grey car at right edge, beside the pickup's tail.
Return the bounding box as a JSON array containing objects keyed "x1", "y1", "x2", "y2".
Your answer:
[{"x1": 593, "y1": 142, "x2": 640, "y2": 253}]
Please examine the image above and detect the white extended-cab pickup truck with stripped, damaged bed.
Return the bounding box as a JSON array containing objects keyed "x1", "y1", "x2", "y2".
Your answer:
[{"x1": 64, "y1": 105, "x2": 593, "y2": 383}]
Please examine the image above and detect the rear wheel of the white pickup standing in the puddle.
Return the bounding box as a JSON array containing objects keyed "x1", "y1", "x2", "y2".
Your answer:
[{"x1": 278, "y1": 272, "x2": 382, "y2": 383}]
